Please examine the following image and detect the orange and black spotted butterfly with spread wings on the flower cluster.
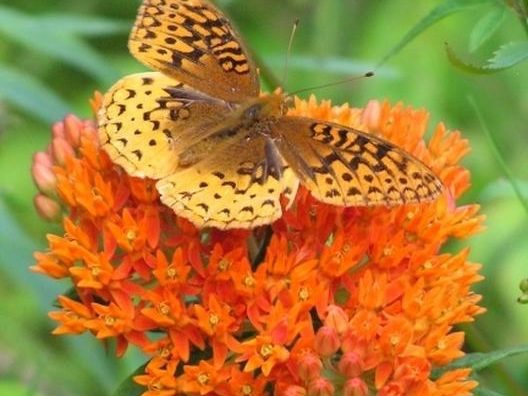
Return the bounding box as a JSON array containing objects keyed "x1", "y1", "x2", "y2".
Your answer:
[{"x1": 98, "y1": 0, "x2": 442, "y2": 229}]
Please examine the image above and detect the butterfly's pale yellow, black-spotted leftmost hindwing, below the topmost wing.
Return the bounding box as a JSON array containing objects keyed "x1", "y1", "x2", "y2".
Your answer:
[{"x1": 98, "y1": 73, "x2": 230, "y2": 179}]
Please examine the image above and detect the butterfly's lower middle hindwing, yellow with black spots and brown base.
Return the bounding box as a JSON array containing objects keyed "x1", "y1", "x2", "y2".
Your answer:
[{"x1": 156, "y1": 130, "x2": 299, "y2": 229}]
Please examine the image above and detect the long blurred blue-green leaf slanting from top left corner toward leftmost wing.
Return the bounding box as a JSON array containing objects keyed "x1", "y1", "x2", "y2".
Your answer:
[{"x1": 0, "y1": 6, "x2": 119, "y2": 84}]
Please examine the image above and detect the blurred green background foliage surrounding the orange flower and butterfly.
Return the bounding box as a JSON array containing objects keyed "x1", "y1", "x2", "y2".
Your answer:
[{"x1": 0, "y1": 0, "x2": 528, "y2": 395}]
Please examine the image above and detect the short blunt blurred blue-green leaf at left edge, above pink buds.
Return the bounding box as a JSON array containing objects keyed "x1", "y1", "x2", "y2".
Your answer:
[{"x1": 0, "y1": 64, "x2": 70, "y2": 123}]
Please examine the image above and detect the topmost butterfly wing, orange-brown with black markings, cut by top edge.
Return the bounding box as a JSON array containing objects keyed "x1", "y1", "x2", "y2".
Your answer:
[{"x1": 129, "y1": 0, "x2": 259, "y2": 103}]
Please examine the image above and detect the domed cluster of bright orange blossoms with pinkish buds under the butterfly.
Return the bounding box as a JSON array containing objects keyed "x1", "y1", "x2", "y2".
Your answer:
[{"x1": 33, "y1": 98, "x2": 483, "y2": 396}]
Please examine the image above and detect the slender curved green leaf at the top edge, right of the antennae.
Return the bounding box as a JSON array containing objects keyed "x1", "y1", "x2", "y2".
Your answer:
[{"x1": 378, "y1": 0, "x2": 493, "y2": 65}]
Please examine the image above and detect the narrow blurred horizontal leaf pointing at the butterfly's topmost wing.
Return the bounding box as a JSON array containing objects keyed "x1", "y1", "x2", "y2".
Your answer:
[{"x1": 38, "y1": 14, "x2": 131, "y2": 36}]
